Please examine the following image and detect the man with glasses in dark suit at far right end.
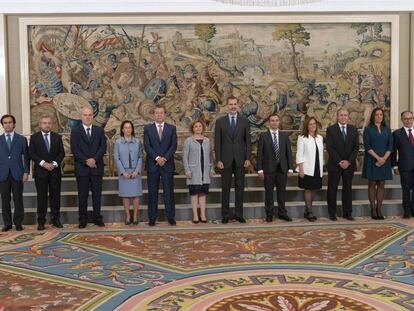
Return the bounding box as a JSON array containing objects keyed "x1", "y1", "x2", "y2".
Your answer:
[{"x1": 392, "y1": 111, "x2": 414, "y2": 219}]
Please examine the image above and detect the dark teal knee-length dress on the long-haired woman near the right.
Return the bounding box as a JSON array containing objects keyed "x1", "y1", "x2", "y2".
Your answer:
[{"x1": 362, "y1": 125, "x2": 393, "y2": 180}]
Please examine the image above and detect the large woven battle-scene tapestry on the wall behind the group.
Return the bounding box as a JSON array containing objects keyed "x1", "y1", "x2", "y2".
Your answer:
[{"x1": 28, "y1": 23, "x2": 391, "y2": 137}]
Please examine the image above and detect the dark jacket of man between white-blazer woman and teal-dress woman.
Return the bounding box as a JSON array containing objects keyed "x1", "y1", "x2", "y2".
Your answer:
[{"x1": 326, "y1": 123, "x2": 359, "y2": 171}]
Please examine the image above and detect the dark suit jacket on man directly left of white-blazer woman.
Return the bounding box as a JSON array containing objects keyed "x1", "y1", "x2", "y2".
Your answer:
[{"x1": 256, "y1": 130, "x2": 293, "y2": 174}]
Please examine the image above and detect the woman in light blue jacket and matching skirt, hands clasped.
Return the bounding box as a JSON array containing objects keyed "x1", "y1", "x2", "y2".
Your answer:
[{"x1": 114, "y1": 121, "x2": 142, "y2": 225}]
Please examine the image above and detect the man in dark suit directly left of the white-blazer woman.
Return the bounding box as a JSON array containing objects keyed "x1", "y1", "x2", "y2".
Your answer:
[{"x1": 257, "y1": 114, "x2": 293, "y2": 222}]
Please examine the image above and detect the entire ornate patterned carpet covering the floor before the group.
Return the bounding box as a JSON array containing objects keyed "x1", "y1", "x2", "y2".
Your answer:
[{"x1": 0, "y1": 219, "x2": 414, "y2": 311}]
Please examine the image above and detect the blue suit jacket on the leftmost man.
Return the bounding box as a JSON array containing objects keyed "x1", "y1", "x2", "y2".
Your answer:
[{"x1": 0, "y1": 132, "x2": 30, "y2": 182}]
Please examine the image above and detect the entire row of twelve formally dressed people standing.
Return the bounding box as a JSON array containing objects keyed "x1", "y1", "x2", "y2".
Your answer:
[{"x1": 0, "y1": 97, "x2": 414, "y2": 232}]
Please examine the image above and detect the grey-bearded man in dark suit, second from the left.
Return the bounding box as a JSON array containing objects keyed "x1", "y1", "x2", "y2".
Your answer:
[{"x1": 29, "y1": 116, "x2": 65, "y2": 230}]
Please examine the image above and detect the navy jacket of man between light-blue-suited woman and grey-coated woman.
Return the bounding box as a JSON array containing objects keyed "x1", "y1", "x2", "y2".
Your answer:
[{"x1": 144, "y1": 123, "x2": 177, "y2": 173}]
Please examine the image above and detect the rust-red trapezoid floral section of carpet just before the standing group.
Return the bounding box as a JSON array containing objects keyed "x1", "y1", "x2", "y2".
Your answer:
[{"x1": 64, "y1": 225, "x2": 401, "y2": 272}]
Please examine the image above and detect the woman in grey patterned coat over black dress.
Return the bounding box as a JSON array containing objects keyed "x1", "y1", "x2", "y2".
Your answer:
[{"x1": 183, "y1": 120, "x2": 214, "y2": 223}]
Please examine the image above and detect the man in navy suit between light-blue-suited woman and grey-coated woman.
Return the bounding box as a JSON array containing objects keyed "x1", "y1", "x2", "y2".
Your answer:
[{"x1": 144, "y1": 106, "x2": 177, "y2": 226}]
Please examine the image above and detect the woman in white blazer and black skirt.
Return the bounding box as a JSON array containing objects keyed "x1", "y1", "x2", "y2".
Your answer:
[{"x1": 296, "y1": 117, "x2": 323, "y2": 221}]
